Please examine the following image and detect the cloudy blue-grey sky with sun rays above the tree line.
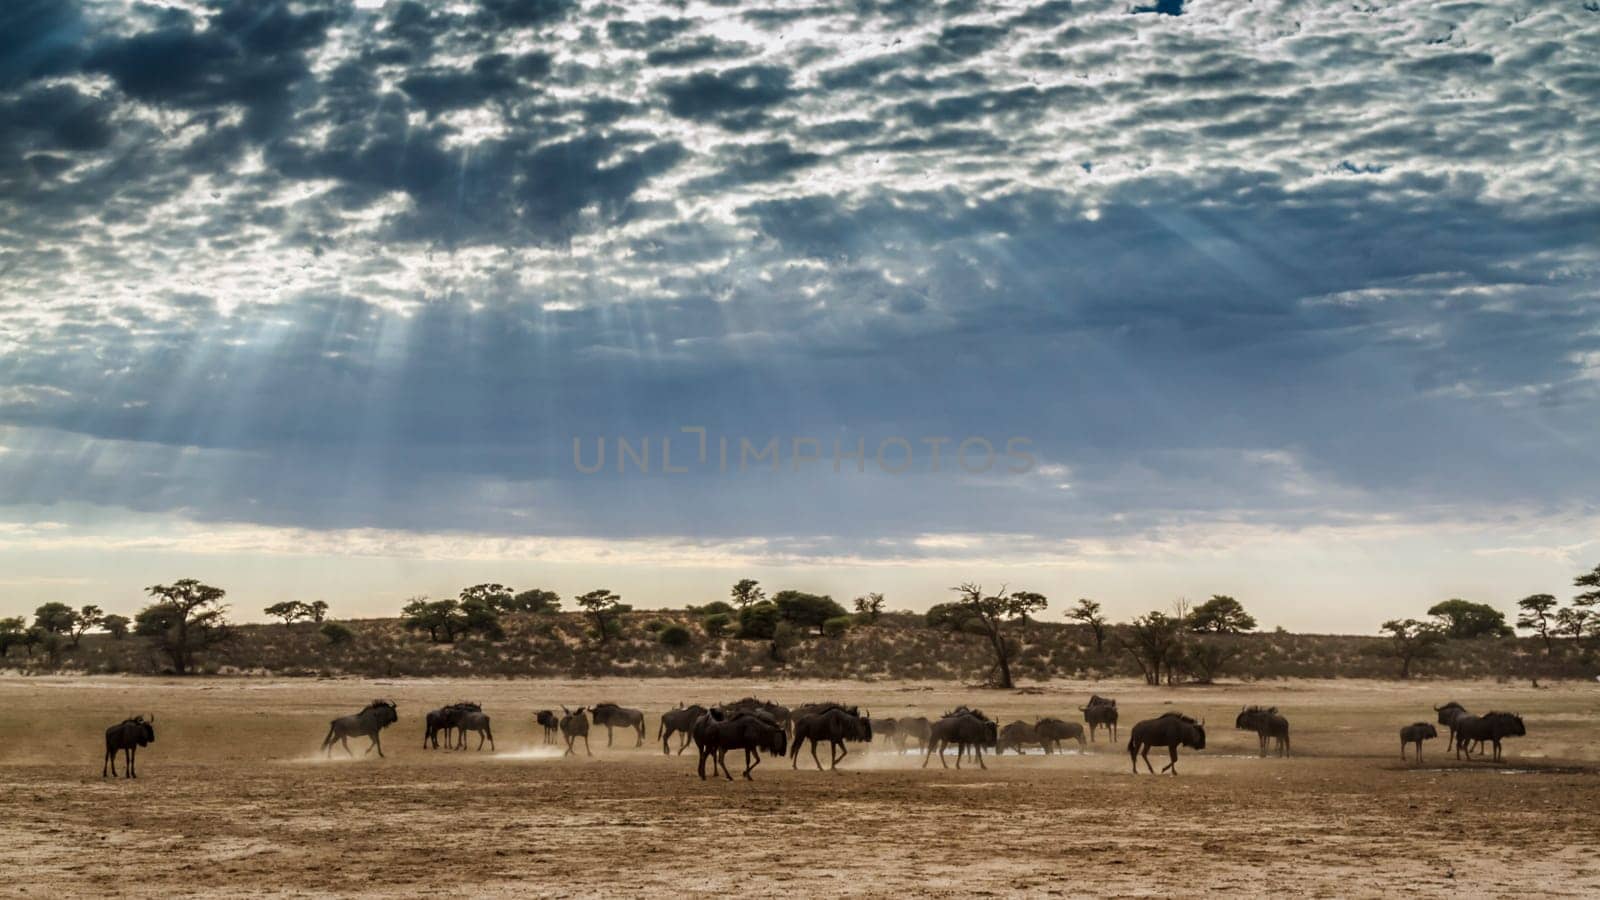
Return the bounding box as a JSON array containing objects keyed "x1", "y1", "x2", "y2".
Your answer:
[{"x1": 0, "y1": 0, "x2": 1600, "y2": 633}]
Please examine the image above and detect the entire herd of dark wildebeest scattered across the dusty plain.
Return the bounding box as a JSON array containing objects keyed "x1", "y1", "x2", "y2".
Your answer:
[{"x1": 101, "y1": 695, "x2": 1528, "y2": 780}]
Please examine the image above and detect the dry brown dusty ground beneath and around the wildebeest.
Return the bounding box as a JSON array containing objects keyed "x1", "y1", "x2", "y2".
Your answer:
[{"x1": 0, "y1": 677, "x2": 1600, "y2": 897}]
